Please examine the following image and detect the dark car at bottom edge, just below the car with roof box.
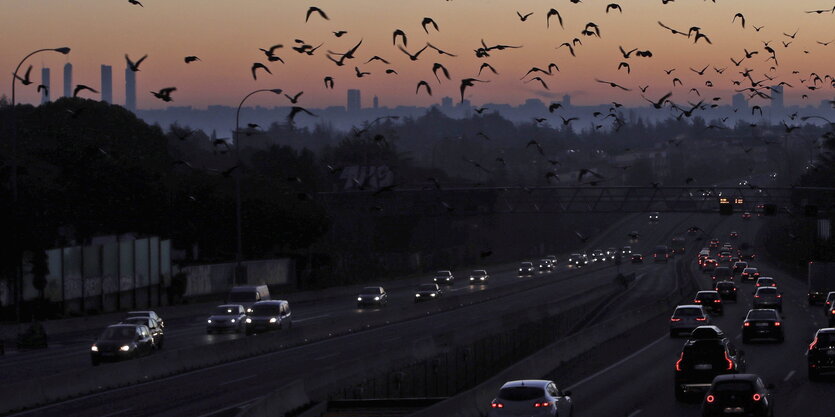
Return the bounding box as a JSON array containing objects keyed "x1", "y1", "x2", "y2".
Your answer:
[{"x1": 702, "y1": 374, "x2": 774, "y2": 417}]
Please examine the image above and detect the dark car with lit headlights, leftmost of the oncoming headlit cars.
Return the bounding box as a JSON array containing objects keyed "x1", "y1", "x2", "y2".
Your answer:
[{"x1": 90, "y1": 324, "x2": 154, "y2": 366}]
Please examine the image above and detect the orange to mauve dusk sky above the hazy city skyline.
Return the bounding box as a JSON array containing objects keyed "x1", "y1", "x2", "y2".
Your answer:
[{"x1": 0, "y1": 0, "x2": 835, "y2": 108}]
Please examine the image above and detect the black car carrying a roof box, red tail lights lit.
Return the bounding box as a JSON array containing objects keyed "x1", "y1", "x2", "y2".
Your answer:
[{"x1": 674, "y1": 326, "x2": 746, "y2": 401}]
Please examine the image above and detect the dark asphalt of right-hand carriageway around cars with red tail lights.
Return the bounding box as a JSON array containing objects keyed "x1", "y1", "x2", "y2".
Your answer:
[{"x1": 560, "y1": 216, "x2": 835, "y2": 417}]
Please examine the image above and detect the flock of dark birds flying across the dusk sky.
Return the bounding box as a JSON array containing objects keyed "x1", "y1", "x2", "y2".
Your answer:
[{"x1": 9, "y1": 0, "x2": 835, "y2": 195}]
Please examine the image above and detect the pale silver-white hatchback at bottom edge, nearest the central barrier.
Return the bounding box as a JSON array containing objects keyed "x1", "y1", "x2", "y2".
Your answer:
[{"x1": 487, "y1": 379, "x2": 574, "y2": 417}]
